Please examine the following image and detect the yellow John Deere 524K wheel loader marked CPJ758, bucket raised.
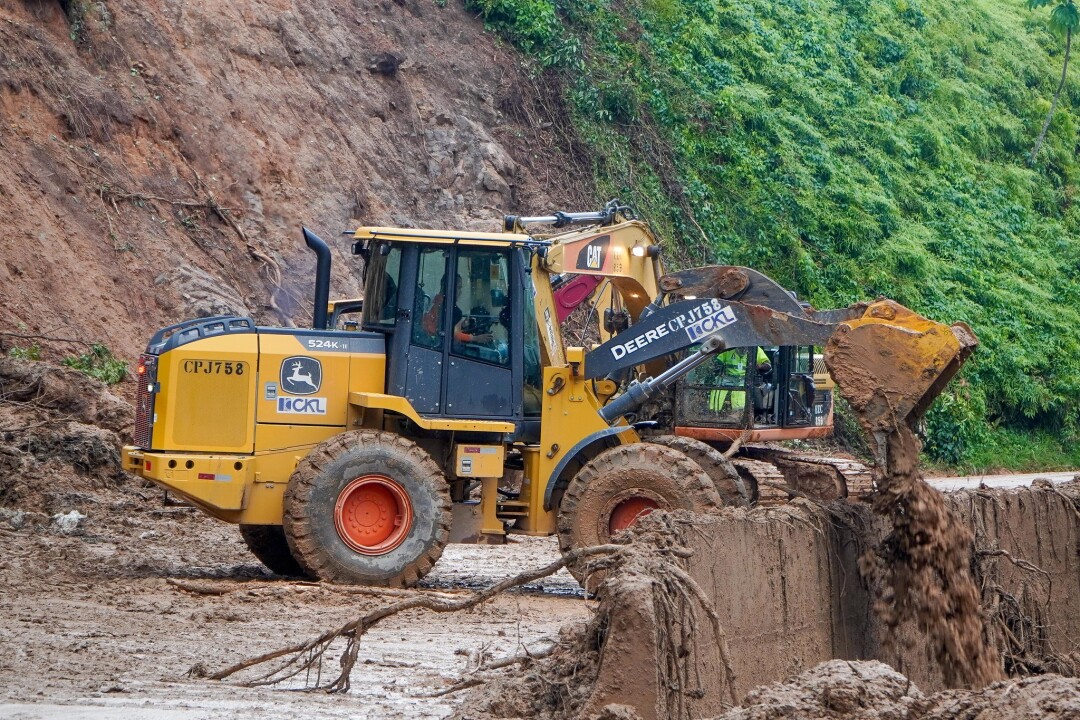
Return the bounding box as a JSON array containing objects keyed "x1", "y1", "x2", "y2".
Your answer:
[{"x1": 123, "y1": 202, "x2": 976, "y2": 586}]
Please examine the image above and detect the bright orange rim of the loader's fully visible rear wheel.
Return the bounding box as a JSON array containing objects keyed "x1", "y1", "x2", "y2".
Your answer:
[{"x1": 334, "y1": 475, "x2": 413, "y2": 555}]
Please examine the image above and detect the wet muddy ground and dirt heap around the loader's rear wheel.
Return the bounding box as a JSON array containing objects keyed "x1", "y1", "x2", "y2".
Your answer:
[{"x1": 0, "y1": 358, "x2": 590, "y2": 720}]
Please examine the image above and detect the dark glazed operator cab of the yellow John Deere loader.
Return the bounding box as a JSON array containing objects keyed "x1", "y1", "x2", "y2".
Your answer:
[{"x1": 363, "y1": 237, "x2": 541, "y2": 437}]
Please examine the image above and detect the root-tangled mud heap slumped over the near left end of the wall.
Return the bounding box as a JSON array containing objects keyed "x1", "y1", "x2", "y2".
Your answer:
[{"x1": 454, "y1": 512, "x2": 737, "y2": 720}]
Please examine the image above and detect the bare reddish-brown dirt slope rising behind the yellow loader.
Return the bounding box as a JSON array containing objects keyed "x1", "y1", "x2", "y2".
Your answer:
[{"x1": 0, "y1": 0, "x2": 588, "y2": 358}]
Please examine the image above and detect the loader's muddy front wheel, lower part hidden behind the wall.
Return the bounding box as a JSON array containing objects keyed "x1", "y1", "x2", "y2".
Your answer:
[{"x1": 557, "y1": 443, "x2": 724, "y2": 590}]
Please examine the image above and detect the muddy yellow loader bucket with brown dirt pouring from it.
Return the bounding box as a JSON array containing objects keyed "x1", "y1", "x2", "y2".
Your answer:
[{"x1": 825, "y1": 307, "x2": 1003, "y2": 688}]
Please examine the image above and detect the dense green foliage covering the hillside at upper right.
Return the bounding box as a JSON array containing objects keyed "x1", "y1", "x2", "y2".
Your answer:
[{"x1": 465, "y1": 0, "x2": 1080, "y2": 466}]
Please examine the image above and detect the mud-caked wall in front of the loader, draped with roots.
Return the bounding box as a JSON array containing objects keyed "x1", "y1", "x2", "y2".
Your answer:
[{"x1": 461, "y1": 483, "x2": 1080, "y2": 720}]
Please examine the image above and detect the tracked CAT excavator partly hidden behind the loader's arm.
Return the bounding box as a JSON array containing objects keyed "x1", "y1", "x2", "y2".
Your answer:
[{"x1": 540, "y1": 208, "x2": 872, "y2": 504}]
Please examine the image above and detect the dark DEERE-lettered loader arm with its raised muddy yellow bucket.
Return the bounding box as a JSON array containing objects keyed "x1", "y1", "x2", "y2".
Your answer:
[{"x1": 584, "y1": 293, "x2": 977, "y2": 444}]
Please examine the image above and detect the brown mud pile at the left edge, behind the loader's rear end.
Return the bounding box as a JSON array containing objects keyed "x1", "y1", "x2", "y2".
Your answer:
[{"x1": 0, "y1": 357, "x2": 134, "y2": 530}]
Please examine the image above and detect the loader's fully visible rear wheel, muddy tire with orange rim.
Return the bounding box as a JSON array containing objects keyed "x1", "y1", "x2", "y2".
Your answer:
[{"x1": 283, "y1": 430, "x2": 450, "y2": 587}]
